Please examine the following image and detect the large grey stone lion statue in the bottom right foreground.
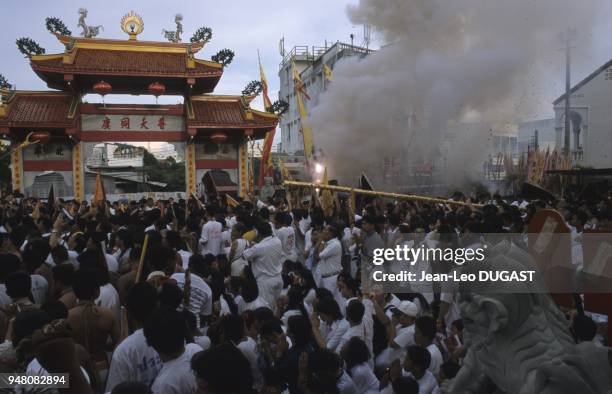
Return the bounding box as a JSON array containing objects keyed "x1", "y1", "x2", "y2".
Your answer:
[{"x1": 443, "y1": 241, "x2": 612, "y2": 394}]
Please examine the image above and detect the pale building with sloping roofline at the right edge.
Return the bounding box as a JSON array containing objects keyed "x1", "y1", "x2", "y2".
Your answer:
[{"x1": 553, "y1": 60, "x2": 612, "y2": 168}]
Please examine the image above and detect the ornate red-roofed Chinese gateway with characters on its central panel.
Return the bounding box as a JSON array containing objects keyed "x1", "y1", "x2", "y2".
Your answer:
[{"x1": 0, "y1": 13, "x2": 278, "y2": 200}]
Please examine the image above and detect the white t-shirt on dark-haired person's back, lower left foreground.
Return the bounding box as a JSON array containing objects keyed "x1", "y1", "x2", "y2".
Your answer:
[{"x1": 106, "y1": 329, "x2": 162, "y2": 391}]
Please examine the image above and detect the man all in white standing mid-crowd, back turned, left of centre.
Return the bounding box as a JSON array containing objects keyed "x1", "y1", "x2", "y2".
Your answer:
[{"x1": 243, "y1": 222, "x2": 284, "y2": 310}]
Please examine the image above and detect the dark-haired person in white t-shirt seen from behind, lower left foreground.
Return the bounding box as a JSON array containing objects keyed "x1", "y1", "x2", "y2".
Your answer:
[{"x1": 106, "y1": 282, "x2": 162, "y2": 391}]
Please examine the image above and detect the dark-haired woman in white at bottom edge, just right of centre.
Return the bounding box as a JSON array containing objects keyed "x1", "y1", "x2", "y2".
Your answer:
[{"x1": 342, "y1": 337, "x2": 380, "y2": 394}]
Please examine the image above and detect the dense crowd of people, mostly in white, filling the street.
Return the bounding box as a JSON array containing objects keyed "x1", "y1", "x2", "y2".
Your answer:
[{"x1": 0, "y1": 185, "x2": 612, "y2": 394}]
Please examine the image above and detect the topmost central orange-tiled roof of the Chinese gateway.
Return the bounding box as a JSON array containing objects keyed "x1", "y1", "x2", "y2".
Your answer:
[{"x1": 30, "y1": 34, "x2": 223, "y2": 95}]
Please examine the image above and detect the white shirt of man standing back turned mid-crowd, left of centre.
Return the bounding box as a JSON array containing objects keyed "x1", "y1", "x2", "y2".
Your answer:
[{"x1": 243, "y1": 236, "x2": 284, "y2": 278}]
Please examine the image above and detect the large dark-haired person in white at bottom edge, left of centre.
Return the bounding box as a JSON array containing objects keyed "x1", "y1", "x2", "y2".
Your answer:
[{"x1": 144, "y1": 309, "x2": 202, "y2": 394}]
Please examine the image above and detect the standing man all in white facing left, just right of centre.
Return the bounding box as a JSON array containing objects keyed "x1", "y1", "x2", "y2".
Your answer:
[{"x1": 315, "y1": 225, "x2": 342, "y2": 295}]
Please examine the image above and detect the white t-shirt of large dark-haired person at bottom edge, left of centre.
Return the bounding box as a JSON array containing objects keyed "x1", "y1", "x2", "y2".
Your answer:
[{"x1": 151, "y1": 343, "x2": 202, "y2": 394}]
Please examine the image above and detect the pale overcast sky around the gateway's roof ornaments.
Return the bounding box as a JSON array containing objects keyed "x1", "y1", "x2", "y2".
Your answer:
[{"x1": 0, "y1": 0, "x2": 376, "y2": 108}]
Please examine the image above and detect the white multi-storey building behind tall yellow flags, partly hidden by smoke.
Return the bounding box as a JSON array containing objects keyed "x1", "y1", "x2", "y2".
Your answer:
[{"x1": 278, "y1": 42, "x2": 373, "y2": 155}]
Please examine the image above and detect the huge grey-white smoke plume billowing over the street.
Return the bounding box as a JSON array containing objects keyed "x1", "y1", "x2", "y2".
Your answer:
[{"x1": 311, "y1": 0, "x2": 610, "y2": 189}]
